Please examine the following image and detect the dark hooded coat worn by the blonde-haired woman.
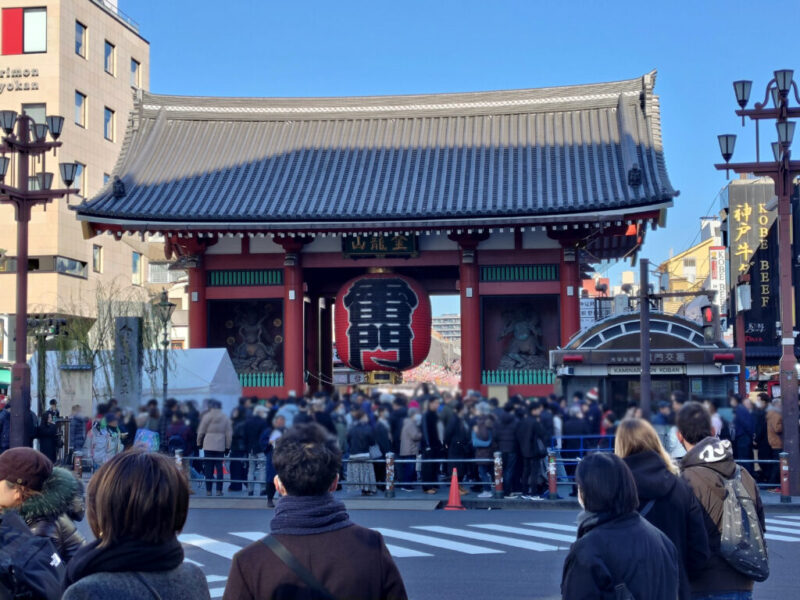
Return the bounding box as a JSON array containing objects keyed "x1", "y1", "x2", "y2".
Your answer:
[{"x1": 624, "y1": 452, "x2": 710, "y2": 600}]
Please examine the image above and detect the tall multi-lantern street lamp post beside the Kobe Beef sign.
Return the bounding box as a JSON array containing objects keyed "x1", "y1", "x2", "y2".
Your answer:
[{"x1": 714, "y1": 69, "x2": 800, "y2": 496}]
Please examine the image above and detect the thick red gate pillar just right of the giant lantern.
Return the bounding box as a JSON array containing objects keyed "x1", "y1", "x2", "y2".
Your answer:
[{"x1": 459, "y1": 242, "x2": 481, "y2": 394}]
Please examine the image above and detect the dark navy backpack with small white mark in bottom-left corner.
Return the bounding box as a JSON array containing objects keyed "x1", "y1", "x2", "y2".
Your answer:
[{"x1": 0, "y1": 511, "x2": 66, "y2": 600}]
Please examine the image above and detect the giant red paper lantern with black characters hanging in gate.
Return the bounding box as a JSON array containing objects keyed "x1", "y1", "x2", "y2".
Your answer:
[{"x1": 335, "y1": 273, "x2": 431, "y2": 371}]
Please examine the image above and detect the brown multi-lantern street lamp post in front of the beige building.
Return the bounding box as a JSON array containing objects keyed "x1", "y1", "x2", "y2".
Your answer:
[{"x1": 0, "y1": 110, "x2": 79, "y2": 447}]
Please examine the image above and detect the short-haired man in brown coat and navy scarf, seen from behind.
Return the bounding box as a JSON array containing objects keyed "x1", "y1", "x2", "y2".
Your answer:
[{"x1": 222, "y1": 424, "x2": 408, "y2": 600}]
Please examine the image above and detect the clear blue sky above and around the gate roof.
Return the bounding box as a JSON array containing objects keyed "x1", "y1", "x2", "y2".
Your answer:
[{"x1": 131, "y1": 0, "x2": 800, "y2": 314}]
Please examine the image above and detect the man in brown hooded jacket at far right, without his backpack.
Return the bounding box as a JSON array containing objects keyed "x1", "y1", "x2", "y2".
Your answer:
[{"x1": 677, "y1": 402, "x2": 765, "y2": 600}]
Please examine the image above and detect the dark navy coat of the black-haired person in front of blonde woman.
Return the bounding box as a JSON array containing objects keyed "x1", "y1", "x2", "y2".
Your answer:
[{"x1": 561, "y1": 512, "x2": 678, "y2": 600}]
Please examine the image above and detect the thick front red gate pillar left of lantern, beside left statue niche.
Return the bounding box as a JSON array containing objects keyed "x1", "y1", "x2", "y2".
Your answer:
[{"x1": 283, "y1": 244, "x2": 305, "y2": 398}]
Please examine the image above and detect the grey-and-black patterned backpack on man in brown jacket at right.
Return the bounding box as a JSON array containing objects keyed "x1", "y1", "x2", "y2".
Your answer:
[{"x1": 720, "y1": 465, "x2": 769, "y2": 581}]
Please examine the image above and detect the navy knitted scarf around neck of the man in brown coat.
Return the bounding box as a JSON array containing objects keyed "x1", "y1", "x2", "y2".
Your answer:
[{"x1": 270, "y1": 493, "x2": 353, "y2": 535}]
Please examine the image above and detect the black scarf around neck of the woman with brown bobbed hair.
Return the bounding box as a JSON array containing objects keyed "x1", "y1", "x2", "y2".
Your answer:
[{"x1": 64, "y1": 537, "x2": 183, "y2": 589}]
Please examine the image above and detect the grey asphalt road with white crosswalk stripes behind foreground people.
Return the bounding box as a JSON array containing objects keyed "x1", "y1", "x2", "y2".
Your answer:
[{"x1": 158, "y1": 509, "x2": 800, "y2": 600}]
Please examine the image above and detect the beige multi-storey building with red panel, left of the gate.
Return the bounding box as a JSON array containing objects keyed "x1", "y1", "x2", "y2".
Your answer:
[{"x1": 0, "y1": 0, "x2": 153, "y2": 360}]
